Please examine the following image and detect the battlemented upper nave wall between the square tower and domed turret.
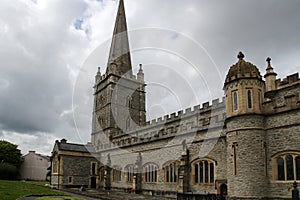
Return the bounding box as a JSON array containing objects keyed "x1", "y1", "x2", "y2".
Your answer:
[{"x1": 96, "y1": 97, "x2": 226, "y2": 151}]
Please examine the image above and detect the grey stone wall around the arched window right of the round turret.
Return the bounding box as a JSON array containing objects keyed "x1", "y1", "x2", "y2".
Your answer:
[{"x1": 266, "y1": 110, "x2": 300, "y2": 198}]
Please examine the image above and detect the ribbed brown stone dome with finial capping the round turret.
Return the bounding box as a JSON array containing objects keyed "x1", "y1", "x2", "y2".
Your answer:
[{"x1": 225, "y1": 52, "x2": 262, "y2": 85}]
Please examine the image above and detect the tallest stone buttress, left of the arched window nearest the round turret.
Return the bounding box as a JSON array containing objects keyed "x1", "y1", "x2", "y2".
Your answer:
[{"x1": 177, "y1": 148, "x2": 189, "y2": 194}]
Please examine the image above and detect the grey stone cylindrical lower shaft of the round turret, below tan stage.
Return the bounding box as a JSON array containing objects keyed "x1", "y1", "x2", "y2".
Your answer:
[{"x1": 227, "y1": 115, "x2": 268, "y2": 198}]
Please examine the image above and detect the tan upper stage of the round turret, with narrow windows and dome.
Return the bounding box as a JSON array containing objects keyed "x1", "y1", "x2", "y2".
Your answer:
[{"x1": 224, "y1": 52, "x2": 264, "y2": 118}]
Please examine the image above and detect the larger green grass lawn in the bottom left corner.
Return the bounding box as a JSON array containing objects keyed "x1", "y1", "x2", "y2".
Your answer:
[{"x1": 0, "y1": 180, "x2": 62, "y2": 200}]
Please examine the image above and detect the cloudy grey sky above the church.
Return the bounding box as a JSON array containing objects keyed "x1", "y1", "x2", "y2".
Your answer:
[{"x1": 0, "y1": 0, "x2": 300, "y2": 155}]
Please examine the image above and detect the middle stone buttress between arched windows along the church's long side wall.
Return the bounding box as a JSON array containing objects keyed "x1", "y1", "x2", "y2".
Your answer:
[{"x1": 132, "y1": 153, "x2": 142, "y2": 194}]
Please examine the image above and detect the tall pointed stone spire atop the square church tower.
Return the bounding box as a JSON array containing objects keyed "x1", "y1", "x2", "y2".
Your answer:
[{"x1": 106, "y1": 0, "x2": 132, "y2": 76}]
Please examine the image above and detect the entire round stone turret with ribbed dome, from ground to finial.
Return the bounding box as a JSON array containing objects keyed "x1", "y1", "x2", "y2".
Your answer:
[{"x1": 224, "y1": 52, "x2": 267, "y2": 199}]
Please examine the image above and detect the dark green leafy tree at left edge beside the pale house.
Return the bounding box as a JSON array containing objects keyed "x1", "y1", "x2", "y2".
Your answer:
[{"x1": 0, "y1": 140, "x2": 23, "y2": 169}]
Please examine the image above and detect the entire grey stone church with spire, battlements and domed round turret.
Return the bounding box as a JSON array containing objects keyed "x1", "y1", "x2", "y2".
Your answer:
[{"x1": 51, "y1": 0, "x2": 300, "y2": 199}]
